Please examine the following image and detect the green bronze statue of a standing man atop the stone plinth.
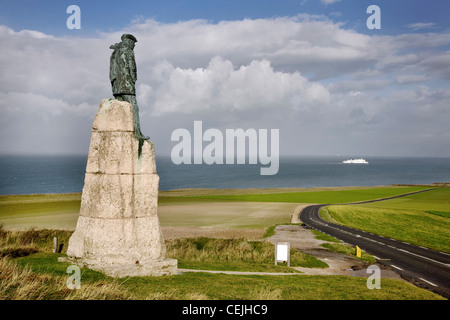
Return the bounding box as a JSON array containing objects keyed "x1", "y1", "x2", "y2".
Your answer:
[{"x1": 109, "y1": 34, "x2": 150, "y2": 140}]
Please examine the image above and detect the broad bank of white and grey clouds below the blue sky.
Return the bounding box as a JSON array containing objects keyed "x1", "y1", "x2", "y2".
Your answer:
[{"x1": 0, "y1": 15, "x2": 450, "y2": 155}]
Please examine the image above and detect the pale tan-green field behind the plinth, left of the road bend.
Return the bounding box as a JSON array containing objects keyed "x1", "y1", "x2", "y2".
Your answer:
[{"x1": 0, "y1": 194, "x2": 296, "y2": 232}]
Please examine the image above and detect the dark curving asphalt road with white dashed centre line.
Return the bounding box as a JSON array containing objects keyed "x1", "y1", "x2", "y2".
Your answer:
[{"x1": 299, "y1": 190, "x2": 450, "y2": 299}]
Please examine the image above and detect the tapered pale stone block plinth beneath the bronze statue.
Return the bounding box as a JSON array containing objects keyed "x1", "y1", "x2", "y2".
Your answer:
[{"x1": 61, "y1": 99, "x2": 177, "y2": 277}]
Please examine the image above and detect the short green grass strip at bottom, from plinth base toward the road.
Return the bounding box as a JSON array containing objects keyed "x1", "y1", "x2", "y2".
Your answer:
[{"x1": 124, "y1": 273, "x2": 438, "y2": 300}]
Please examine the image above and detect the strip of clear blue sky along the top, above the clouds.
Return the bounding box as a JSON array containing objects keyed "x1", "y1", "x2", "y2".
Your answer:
[{"x1": 0, "y1": 0, "x2": 450, "y2": 36}]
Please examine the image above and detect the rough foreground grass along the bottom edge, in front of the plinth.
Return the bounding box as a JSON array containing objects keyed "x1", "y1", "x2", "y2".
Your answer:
[{"x1": 0, "y1": 240, "x2": 442, "y2": 300}]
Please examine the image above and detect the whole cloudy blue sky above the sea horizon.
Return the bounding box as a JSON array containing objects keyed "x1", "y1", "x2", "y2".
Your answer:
[{"x1": 0, "y1": 0, "x2": 450, "y2": 157}]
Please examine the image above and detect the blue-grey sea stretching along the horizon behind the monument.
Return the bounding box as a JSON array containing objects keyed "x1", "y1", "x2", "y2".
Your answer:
[{"x1": 0, "y1": 155, "x2": 450, "y2": 195}]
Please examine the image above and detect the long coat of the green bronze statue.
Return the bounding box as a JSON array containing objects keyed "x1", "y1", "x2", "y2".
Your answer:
[{"x1": 109, "y1": 45, "x2": 137, "y2": 96}]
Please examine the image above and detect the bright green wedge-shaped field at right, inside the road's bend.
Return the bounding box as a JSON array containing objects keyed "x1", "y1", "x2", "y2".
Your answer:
[{"x1": 321, "y1": 188, "x2": 450, "y2": 253}]
